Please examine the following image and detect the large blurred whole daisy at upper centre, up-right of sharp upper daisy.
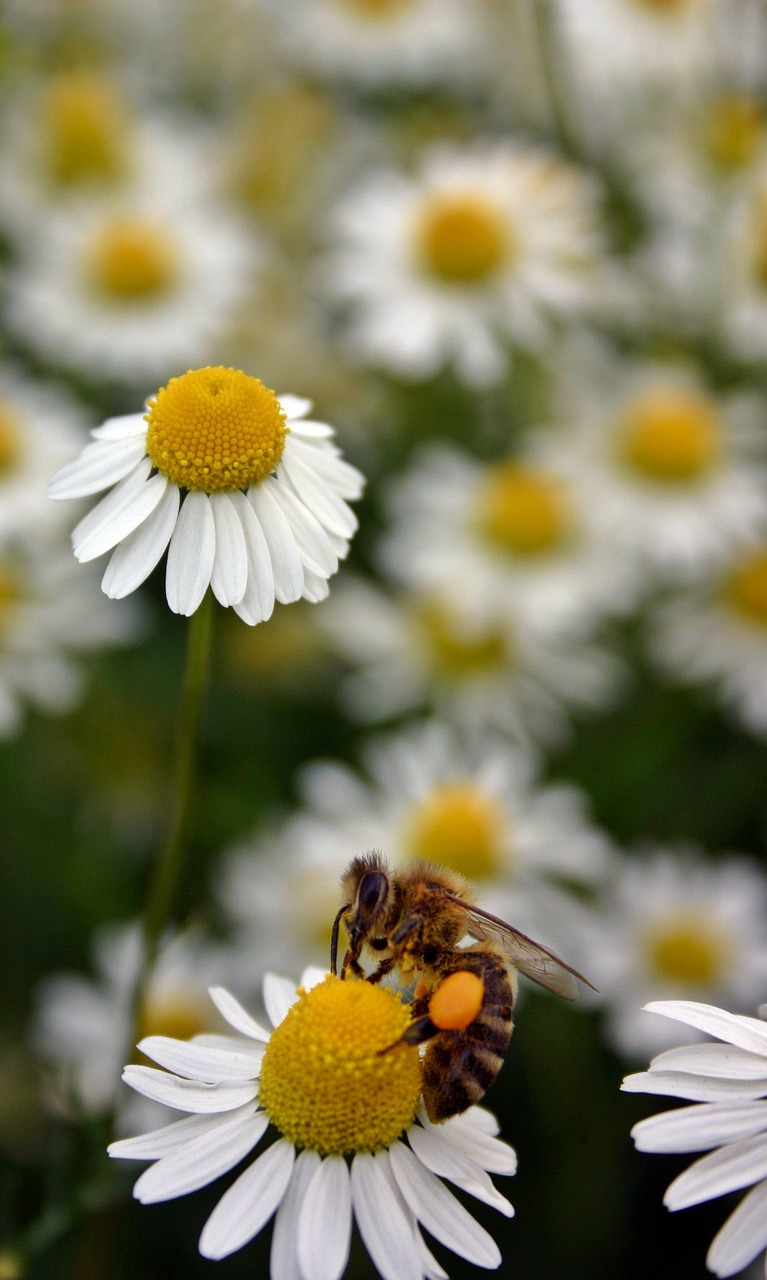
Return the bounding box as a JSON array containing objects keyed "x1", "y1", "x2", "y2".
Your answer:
[{"x1": 325, "y1": 142, "x2": 599, "y2": 385}]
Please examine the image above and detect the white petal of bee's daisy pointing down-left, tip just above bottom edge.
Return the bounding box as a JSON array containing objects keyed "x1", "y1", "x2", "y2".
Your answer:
[{"x1": 200, "y1": 1138, "x2": 296, "y2": 1261}]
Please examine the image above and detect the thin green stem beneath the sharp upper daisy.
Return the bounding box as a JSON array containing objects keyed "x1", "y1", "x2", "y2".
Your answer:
[{"x1": 129, "y1": 591, "x2": 214, "y2": 1055}]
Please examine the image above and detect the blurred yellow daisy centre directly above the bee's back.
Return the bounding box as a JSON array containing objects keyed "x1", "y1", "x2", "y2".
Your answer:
[{"x1": 405, "y1": 782, "x2": 506, "y2": 879}]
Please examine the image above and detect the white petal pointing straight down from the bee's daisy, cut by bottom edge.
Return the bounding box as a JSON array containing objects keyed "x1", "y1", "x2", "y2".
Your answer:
[{"x1": 298, "y1": 1156, "x2": 352, "y2": 1280}]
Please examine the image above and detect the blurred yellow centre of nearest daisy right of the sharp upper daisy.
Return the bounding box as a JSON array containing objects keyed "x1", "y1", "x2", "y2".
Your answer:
[{"x1": 478, "y1": 462, "x2": 571, "y2": 556}]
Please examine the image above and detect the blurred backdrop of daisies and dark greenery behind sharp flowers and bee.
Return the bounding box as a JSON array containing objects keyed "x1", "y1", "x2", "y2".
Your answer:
[{"x1": 0, "y1": 0, "x2": 767, "y2": 1280}]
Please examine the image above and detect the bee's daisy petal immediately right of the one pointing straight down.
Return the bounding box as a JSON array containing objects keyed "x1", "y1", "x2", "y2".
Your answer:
[{"x1": 351, "y1": 1152, "x2": 423, "y2": 1280}]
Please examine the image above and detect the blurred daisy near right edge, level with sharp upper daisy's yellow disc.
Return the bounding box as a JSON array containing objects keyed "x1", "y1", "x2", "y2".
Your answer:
[{"x1": 551, "y1": 342, "x2": 767, "y2": 577}]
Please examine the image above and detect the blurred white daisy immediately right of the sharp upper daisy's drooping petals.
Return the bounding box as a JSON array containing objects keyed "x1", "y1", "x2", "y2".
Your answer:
[{"x1": 379, "y1": 445, "x2": 642, "y2": 639}]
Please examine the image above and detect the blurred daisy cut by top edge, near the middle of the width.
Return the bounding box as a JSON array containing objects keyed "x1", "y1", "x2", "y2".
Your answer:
[{"x1": 270, "y1": 0, "x2": 484, "y2": 88}]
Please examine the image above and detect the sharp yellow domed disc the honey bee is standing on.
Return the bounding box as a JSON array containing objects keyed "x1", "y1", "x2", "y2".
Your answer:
[{"x1": 259, "y1": 975, "x2": 421, "y2": 1156}]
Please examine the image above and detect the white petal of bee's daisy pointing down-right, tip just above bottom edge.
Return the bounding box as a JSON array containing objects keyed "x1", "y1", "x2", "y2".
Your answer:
[{"x1": 389, "y1": 1142, "x2": 501, "y2": 1267}]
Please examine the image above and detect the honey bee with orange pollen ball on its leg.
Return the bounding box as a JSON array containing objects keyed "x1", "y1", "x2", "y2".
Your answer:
[{"x1": 330, "y1": 851, "x2": 592, "y2": 1123}]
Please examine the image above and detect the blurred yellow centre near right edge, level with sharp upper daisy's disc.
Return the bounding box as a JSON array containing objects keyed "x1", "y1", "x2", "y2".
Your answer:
[{"x1": 621, "y1": 389, "x2": 722, "y2": 484}]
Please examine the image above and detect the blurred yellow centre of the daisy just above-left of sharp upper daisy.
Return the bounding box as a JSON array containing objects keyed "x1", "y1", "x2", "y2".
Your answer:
[{"x1": 85, "y1": 218, "x2": 179, "y2": 303}]
